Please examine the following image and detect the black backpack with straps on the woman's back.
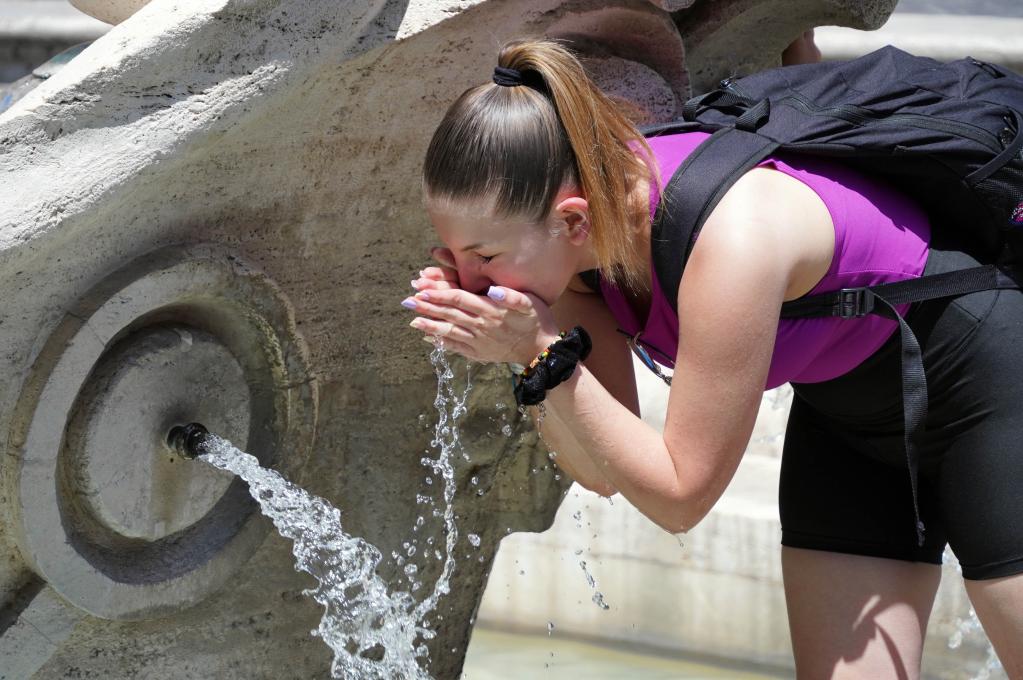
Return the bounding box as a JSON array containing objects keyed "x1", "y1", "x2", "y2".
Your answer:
[{"x1": 643, "y1": 46, "x2": 1023, "y2": 545}]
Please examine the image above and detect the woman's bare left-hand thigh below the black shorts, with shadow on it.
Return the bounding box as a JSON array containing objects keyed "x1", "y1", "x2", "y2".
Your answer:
[{"x1": 782, "y1": 547, "x2": 941, "y2": 680}]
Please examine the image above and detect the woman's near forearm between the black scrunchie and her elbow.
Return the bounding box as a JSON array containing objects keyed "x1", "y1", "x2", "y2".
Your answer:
[{"x1": 544, "y1": 365, "x2": 716, "y2": 533}]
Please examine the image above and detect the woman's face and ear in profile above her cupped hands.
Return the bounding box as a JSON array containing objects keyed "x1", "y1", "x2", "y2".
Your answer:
[{"x1": 427, "y1": 190, "x2": 595, "y2": 306}]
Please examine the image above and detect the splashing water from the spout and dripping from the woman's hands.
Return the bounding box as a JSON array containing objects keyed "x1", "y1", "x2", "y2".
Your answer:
[{"x1": 199, "y1": 346, "x2": 472, "y2": 680}]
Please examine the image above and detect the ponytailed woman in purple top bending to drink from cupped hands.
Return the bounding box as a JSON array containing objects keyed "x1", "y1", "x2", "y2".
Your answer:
[{"x1": 402, "y1": 41, "x2": 1023, "y2": 680}]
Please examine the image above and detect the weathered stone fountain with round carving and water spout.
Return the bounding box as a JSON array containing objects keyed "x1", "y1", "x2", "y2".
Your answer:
[{"x1": 0, "y1": 0, "x2": 895, "y2": 679}]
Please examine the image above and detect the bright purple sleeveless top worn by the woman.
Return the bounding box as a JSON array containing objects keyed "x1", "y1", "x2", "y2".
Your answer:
[{"x1": 601, "y1": 132, "x2": 930, "y2": 390}]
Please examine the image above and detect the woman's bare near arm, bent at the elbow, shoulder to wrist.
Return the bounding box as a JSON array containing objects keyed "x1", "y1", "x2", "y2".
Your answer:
[{"x1": 545, "y1": 193, "x2": 789, "y2": 533}]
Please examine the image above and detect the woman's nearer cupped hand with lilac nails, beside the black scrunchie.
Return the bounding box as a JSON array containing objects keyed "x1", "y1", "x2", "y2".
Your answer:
[{"x1": 403, "y1": 286, "x2": 558, "y2": 364}]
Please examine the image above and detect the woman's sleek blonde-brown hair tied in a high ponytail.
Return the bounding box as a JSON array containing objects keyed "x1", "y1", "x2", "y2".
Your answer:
[{"x1": 424, "y1": 40, "x2": 656, "y2": 290}]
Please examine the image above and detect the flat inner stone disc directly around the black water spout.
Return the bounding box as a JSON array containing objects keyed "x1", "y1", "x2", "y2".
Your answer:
[{"x1": 62, "y1": 325, "x2": 252, "y2": 542}]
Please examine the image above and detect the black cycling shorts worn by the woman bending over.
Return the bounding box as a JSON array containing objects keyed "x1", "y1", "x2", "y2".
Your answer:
[{"x1": 780, "y1": 246, "x2": 1023, "y2": 579}]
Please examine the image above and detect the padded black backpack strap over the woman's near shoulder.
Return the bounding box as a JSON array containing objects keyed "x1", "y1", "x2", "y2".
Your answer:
[{"x1": 650, "y1": 128, "x2": 779, "y2": 309}]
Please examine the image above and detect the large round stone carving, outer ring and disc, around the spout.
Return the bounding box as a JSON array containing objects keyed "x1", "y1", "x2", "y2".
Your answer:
[{"x1": 12, "y1": 245, "x2": 316, "y2": 619}]
